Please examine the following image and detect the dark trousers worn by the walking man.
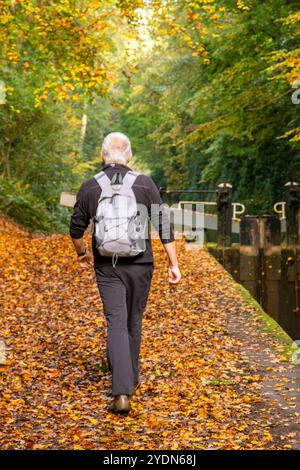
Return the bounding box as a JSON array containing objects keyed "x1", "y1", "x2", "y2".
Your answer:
[{"x1": 95, "y1": 263, "x2": 153, "y2": 395}]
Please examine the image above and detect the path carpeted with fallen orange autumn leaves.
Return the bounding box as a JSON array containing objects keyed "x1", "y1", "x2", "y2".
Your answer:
[{"x1": 0, "y1": 220, "x2": 300, "y2": 449}]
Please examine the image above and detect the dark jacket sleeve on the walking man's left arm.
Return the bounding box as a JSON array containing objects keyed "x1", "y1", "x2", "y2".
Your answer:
[{"x1": 69, "y1": 183, "x2": 91, "y2": 238}]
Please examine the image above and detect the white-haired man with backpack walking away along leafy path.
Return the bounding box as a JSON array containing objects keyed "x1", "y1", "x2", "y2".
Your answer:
[{"x1": 70, "y1": 132, "x2": 181, "y2": 413}]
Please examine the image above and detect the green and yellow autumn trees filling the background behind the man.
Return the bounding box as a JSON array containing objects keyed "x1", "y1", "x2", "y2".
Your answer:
[{"x1": 0, "y1": 0, "x2": 300, "y2": 230}]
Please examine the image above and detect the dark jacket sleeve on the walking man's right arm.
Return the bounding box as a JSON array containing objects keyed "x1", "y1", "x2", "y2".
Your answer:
[{"x1": 148, "y1": 178, "x2": 174, "y2": 244}]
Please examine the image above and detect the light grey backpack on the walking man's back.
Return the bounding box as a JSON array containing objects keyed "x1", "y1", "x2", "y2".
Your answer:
[{"x1": 94, "y1": 170, "x2": 147, "y2": 258}]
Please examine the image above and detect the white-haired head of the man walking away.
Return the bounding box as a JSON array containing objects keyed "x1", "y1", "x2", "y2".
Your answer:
[{"x1": 101, "y1": 132, "x2": 132, "y2": 165}]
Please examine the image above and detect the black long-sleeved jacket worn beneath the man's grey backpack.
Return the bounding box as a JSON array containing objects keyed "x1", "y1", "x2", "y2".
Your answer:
[{"x1": 70, "y1": 164, "x2": 174, "y2": 265}]
